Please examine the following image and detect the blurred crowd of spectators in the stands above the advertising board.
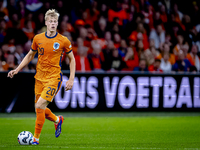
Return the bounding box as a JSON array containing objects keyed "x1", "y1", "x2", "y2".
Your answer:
[{"x1": 0, "y1": 0, "x2": 200, "y2": 73}]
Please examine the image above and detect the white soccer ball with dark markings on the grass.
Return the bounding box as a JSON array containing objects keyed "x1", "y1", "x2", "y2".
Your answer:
[{"x1": 17, "y1": 131, "x2": 33, "y2": 145}]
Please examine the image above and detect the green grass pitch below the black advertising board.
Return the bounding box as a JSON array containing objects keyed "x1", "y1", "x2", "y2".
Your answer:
[{"x1": 0, "y1": 112, "x2": 200, "y2": 150}]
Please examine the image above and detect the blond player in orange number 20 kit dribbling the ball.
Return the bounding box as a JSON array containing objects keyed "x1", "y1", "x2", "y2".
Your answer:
[{"x1": 8, "y1": 9, "x2": 75, "y2": 145}]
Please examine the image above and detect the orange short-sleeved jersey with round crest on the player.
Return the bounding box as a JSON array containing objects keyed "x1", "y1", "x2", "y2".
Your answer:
[{"x1": 31, "y1": 32, "x2": 72, "y2": 82}]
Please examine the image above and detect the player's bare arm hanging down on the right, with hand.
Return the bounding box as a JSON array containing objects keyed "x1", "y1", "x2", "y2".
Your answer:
[{"x1": 65, "y1": 52, "x2": 76, "y2": 91}]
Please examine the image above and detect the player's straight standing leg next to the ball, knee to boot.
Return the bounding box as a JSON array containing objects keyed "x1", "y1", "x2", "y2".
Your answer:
[{"x1": 32, "y1": 97, "x2": 49, "y2": 145}]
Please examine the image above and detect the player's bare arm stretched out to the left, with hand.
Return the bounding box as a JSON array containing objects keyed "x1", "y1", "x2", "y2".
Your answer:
[{"x1": 8, "y1": 50, "x2": 37, "y2": 78}]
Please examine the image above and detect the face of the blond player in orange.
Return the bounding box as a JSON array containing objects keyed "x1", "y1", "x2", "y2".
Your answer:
[{"x1": 45, "y1": 17, "x2": 58, "y2": 32}]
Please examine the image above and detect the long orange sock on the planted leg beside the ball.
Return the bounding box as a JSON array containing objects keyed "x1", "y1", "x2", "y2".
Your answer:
[{"x1": 34, "y1": 108, "x2": 45, "y2": 139}]
